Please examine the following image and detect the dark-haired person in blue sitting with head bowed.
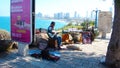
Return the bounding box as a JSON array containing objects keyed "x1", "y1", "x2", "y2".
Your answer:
[{"x1": 47, "y1": 21, "x2": 62, "y2": 49}]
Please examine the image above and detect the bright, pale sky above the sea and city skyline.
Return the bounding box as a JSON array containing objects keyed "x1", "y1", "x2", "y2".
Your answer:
[{"x1": 0, "y1": 0, "x2": 113, "y2": 17}]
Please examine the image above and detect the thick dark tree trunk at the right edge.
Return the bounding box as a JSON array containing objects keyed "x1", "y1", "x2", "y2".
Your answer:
[{"x1": 105, "y1": 0, "x2": 120, "y2": 68}]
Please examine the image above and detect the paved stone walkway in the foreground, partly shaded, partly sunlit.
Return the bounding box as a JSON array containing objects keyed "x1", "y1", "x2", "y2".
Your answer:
[{"x1": 0, "y1": 32, "x2": 109, "y2": 68}]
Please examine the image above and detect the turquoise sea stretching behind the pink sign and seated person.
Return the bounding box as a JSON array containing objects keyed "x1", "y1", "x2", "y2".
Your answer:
[{"x1": 0, "y1": 17, "x2": 67, "y2": 32}]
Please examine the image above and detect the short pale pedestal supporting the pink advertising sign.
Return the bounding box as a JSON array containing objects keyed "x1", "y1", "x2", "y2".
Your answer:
[{"x1": 18, "y1": 42, "x2": 29, "y2": 56}]
